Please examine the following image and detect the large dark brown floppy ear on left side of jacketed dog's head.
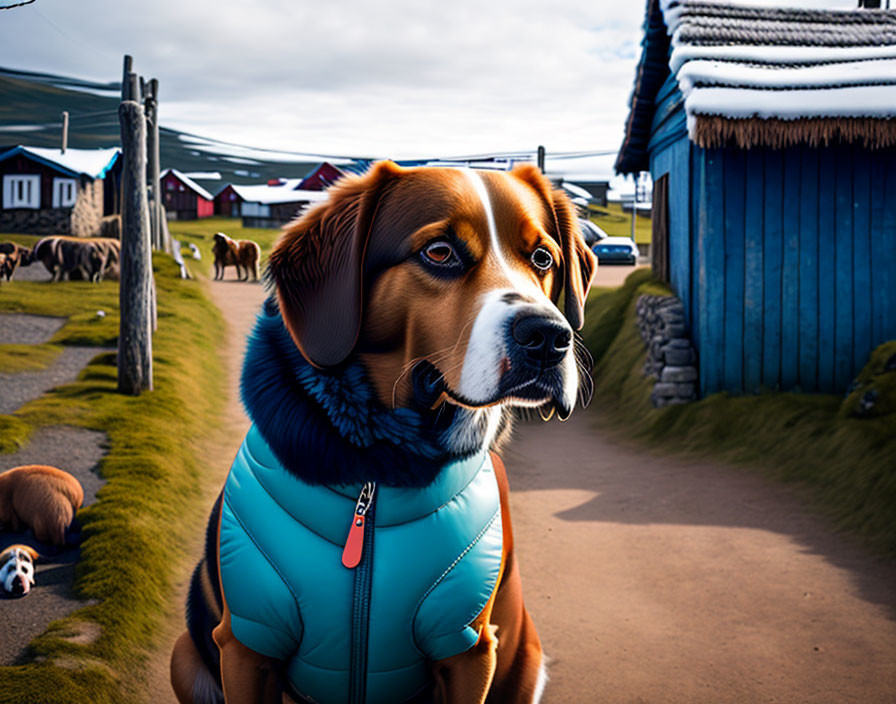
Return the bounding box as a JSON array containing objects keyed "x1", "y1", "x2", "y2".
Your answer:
[{"x1": 268, "y1": 161, "x2": 401, "y2": 367}]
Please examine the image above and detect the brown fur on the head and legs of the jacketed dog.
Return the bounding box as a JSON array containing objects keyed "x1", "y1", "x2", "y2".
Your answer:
[{"x1": 171, "y1": 162, "x2": 596, "y2": 704}]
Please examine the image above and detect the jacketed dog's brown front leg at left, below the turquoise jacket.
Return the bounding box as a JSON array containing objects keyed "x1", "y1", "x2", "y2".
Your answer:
[{"x1": 212, "y1": 604, "x2": 283, "y2": 704}]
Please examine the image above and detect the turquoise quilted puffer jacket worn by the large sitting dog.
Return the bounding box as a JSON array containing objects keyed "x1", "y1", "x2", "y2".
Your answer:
[{"x1": 221, "y1": 426, "x2": 503, "y2": 704}]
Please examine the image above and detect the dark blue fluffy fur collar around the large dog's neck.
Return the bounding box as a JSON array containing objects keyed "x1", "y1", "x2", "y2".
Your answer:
[{"x1": 240, "y1": 299, "x2": 479, "y2": 487}]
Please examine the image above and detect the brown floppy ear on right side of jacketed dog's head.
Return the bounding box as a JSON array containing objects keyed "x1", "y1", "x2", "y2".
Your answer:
[{"x1": 513, "y1": 164, "x2": 597, "y2": 330}]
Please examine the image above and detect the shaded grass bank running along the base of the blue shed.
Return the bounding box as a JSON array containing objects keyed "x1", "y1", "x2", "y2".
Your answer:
[{"x1": 582, "y1": 270, "x2": 896, "y2": 556}]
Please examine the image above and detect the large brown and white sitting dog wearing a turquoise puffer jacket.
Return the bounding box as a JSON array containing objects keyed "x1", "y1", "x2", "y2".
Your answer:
[{"x1": 171, "y1": 162, "x2": 596, "y2": 704}]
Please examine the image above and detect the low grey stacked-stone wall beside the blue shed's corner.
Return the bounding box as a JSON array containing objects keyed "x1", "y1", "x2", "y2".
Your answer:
[{"x1": 636, "y1": 296, "x2": 698, "y2": 408}]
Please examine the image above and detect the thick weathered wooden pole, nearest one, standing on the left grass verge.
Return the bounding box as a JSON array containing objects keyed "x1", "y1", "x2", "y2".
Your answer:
[{"x1": 118, "y1": 56, "x2": 154, "y2": 395}]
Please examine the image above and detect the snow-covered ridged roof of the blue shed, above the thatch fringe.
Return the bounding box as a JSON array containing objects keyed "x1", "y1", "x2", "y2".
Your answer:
[{"x1": 660, "y1": 0, "x2": 896, "y2": 129}]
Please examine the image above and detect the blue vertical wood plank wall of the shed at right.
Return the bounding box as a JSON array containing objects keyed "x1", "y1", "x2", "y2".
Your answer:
[{"x1": 651, "y1": 144, "x2": 896, "y2": 394}]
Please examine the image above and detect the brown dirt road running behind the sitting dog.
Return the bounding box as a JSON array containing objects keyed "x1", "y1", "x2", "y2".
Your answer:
[{"x1": 150, "y1": 281, "x2": 896, "y2": 704}]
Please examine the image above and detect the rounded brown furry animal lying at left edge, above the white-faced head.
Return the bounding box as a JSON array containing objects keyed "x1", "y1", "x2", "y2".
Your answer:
[{"x1": 0, "y1": 464, "x2": 84, "y2": 546}]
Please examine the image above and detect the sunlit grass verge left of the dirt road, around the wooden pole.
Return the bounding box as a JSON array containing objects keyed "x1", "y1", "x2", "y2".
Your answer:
[{"x1": 0, "y1": 256, "x2": 225, "y2": 704}]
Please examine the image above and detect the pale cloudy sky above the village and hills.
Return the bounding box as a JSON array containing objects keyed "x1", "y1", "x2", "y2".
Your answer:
[{"x1": 0, "y1": 0, "x2": 854, "y2": 179}]
